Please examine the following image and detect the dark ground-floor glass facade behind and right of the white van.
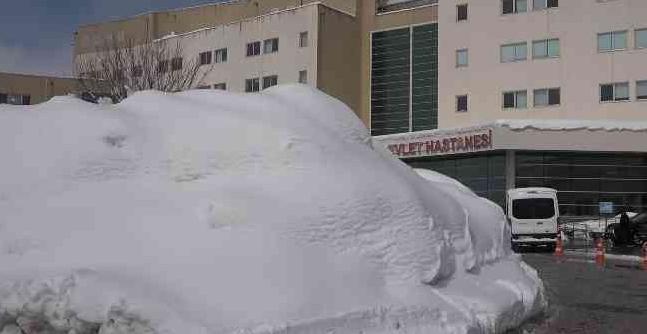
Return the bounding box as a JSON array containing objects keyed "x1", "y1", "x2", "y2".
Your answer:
[{"x1": 515, "y1": 152, "x2": 647, "y2": 216}]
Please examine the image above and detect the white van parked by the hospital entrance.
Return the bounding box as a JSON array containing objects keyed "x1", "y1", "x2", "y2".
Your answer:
[{"x1": 506, "y1": 188, "x2": 559, "y2": 249}]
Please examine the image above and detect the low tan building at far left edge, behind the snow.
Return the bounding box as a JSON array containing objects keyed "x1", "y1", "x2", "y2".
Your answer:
[{"x1": 0, "y1": 73, "x2": 77, "y2": 104}]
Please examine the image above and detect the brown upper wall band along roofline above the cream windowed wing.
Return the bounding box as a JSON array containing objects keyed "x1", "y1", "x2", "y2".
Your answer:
[{"x1": 75, "y1": 0, "x2": 355, "y2": 55}]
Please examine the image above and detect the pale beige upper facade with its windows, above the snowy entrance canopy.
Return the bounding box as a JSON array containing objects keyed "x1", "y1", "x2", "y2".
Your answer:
[{"x1": 439, "y1": 0, "x2": 647, "y2": 128}]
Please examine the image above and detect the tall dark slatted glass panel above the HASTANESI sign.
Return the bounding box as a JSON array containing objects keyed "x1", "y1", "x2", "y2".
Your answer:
[{"x1": 371, "y1": 23, "x2": 438, "y2": 136}]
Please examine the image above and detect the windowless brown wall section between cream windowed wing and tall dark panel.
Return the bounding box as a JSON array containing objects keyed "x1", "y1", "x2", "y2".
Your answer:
[{"x1": 317, "y1": 6, "x2": 361, "y2": 116}]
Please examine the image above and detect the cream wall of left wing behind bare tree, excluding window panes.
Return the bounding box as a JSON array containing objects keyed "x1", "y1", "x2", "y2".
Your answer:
[{"x1": 169, "y1": 5, "x2": 322, "y2": 92}]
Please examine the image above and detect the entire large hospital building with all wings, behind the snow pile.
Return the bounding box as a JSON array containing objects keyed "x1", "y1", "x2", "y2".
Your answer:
[{"x1": 76, "y1": 0, "x2": 647, "y2": 216}]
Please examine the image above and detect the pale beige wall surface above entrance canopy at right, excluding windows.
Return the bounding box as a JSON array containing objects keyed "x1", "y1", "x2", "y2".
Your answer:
[{"x1": 439, "y1": 0, "x2": 647, "y2": 128}]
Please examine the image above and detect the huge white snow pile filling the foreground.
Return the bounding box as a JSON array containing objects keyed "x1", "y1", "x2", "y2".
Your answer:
[{"x1": 0, "y1": 86, "x2": 545, "y2": 334}]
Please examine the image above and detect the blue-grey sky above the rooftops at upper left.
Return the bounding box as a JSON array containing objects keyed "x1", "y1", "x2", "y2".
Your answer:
[{"x1": 0, "y1": 0, "x2": 225, "y2": 75}]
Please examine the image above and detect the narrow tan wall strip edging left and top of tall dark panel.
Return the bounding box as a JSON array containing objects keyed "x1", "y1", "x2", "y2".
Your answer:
[{"x1": 357, "y1": 0, "x2": 442, "y2": 126}]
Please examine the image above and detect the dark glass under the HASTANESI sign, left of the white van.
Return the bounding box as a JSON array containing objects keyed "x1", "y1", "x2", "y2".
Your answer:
[{"x1": 406, "y1": 152, "x2": 506, "y2": 207}]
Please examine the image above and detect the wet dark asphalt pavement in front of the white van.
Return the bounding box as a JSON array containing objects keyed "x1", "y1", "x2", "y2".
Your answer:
[{"x1": 512, "y1": 250, "x2": 647, "y2": 334}]
